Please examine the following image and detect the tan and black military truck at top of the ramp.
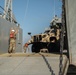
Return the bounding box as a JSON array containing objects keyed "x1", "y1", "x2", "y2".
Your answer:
[{"x1": 24, "y1": 16, "x2": 61, "y2": 53}]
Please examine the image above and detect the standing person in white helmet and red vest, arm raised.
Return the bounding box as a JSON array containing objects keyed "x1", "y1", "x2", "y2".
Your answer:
[{"x1": 8, "y1": 28, "x2": 18, "y2": 53}]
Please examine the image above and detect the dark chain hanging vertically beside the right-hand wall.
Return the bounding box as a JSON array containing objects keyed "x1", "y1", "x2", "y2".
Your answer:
[{"x1": 59, "y1": 0, "x2": 65, "y2": 75}]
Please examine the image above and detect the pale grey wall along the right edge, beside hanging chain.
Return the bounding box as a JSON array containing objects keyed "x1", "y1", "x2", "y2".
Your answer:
[{"x1": 65, "y1": 0, "x2": 76, "y2": 65}]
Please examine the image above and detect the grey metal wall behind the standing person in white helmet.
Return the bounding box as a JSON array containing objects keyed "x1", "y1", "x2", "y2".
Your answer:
[{"x1": 0, "y1": 17, "x2": 22, "y2": 53}]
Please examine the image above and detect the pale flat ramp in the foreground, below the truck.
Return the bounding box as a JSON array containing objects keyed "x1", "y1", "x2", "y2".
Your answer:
[{"x1": 0, "y1": 53, "x2": 67, "y2": 75}]
